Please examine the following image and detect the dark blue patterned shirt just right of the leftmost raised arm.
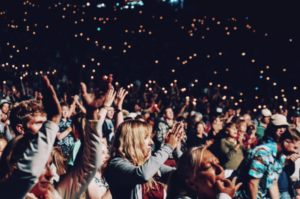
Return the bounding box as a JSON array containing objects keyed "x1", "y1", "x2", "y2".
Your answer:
[{"x1": 57, "y1": 119, "x2": 75, "y2": 155}]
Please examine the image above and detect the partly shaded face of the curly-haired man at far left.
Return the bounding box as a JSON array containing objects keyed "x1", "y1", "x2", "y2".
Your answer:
[{"x1": 24, "y1": 113, "x2": 47, "y2": 134}]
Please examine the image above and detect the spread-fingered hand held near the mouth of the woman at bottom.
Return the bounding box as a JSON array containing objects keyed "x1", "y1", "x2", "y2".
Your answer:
[{"x1": 216, "y1": 177, "x2": 242, "y2": 198}]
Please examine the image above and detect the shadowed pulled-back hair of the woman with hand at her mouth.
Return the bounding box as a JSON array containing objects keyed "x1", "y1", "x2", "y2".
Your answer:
[{"x1": 167, "y1": 146, "x2": 206, "y2": 199}]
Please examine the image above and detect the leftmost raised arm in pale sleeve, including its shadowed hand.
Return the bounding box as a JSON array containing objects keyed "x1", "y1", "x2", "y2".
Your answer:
[{"x1": 0, "y1": 76, "x2": 61, "y2": 198}]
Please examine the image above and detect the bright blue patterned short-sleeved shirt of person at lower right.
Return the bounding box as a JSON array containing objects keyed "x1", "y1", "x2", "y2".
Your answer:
[{"x1": 235, "y1": 142, "x2": 286, "y2": 199}]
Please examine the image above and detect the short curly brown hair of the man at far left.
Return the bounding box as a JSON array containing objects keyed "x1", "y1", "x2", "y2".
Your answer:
[{"x1": 9, "y1": 100, "x2": 47, "y2": 135}]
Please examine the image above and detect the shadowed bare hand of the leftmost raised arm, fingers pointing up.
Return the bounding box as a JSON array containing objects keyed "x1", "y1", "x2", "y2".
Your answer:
[{"x1": 42, "y1": 76, "x2": 62, "y2": 125}]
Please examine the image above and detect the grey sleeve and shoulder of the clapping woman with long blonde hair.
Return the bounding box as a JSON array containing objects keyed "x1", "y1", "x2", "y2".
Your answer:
[{"x1": 105, "y1": 145, "x2": 173, "y2": 186}]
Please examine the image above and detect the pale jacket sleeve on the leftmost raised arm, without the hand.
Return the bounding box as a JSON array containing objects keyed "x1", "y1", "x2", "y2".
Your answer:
[{"x1": 0, "y1": 121, "x2": 58, "y2": 199}]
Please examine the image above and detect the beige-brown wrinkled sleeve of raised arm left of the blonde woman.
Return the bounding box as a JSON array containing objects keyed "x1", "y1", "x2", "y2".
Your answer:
[{"x1": 56, "y1": 120, "x2": 102, "y2": 199}]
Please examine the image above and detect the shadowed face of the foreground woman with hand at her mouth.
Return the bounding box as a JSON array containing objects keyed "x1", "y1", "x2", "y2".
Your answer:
[{"x1": 188, "y1": 150, "x2": 225, "y2": 198}]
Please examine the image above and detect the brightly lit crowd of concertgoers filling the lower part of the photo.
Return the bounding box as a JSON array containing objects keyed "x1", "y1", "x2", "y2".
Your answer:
[{"x1": 0, "y1": 75, "x2": 300, "y2": 199}]
